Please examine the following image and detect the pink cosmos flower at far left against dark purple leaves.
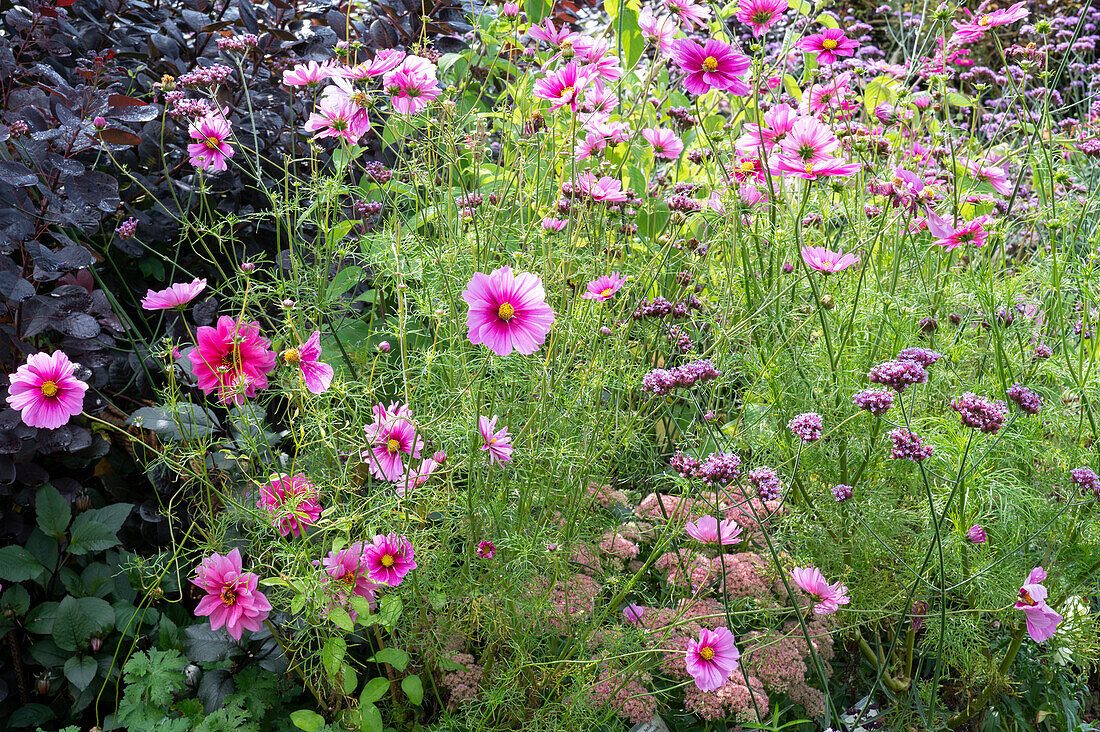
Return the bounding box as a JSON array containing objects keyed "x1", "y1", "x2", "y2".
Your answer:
[{"x1": 8, "y1": 351, "x2": 88, "y2": 429}]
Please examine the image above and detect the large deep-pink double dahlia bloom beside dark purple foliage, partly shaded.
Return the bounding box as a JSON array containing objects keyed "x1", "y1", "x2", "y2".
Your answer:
[{"x1": 187, "y1": 315, "x2": 275, "y2": 406}]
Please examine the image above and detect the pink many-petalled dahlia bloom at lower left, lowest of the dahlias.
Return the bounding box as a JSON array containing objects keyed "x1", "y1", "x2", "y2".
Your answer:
[{"x1": 191, "y1": 549, "x2": 272, "y2": 641}]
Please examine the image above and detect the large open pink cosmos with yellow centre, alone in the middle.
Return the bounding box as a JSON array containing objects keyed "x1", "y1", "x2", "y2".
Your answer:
[{"x1": 462, "y1": 266, "x2": 554, "y2": 356}]
